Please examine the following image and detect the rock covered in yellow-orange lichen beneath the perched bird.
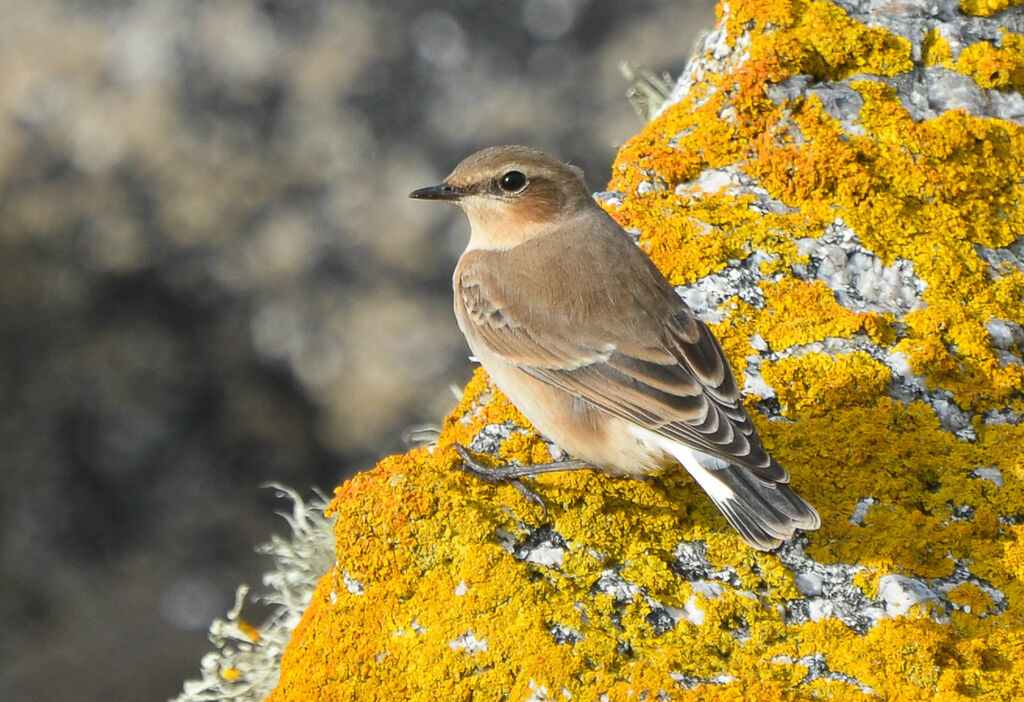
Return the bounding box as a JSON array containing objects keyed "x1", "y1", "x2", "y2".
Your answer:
[{"x1": 270, "y1": 0, "x2": 1024, "y2": 701}]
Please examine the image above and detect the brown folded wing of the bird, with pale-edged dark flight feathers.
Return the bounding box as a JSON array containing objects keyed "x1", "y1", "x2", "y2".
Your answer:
[{"x1": 459, "y1": 264, "x2": 788, "y2": 482}]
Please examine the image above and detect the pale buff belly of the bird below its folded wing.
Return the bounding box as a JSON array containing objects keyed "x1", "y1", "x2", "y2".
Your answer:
[{"x1": 474, "y1": 349, "x2": 675, "y2": 476}]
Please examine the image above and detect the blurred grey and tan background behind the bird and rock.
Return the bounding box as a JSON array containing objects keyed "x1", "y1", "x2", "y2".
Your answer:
[{"x1": 0, "y1": 0, "x2": 714, "y2": 702}]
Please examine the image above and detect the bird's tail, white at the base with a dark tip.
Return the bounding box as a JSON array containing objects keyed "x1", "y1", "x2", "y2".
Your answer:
[{"x1": 665, "y1": 442, "x2": 821, "y2": 551}]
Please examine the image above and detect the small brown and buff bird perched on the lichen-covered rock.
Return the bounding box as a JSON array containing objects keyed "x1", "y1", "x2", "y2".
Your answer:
[{"x1": 410, "y1": 145, "x2": 820, "y2": 551}]
